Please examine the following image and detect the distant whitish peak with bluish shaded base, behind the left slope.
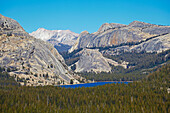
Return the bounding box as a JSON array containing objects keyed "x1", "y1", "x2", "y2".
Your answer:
[{"x1": 30, "y1": 28, "x2": 79, "y2": 52}]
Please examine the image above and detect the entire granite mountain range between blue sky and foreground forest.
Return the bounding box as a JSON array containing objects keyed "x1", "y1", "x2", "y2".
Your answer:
[{"x1": 0, "y1": 15, "x2": 170, "y2": 86}]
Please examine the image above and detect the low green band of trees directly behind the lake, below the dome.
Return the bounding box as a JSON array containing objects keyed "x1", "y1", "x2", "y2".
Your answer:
[{"x1": 78, "y1": 67, "x2": 146, "y2": 81}]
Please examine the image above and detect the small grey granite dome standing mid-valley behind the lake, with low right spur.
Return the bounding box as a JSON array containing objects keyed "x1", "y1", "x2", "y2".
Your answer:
[{"x1": 72, "y1": 49, "x2": 126, "y2": 73}]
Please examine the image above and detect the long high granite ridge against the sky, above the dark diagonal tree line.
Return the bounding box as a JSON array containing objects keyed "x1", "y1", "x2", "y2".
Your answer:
[{"x1": 69, "y1": 21, "x2": 170, "y2": 52}]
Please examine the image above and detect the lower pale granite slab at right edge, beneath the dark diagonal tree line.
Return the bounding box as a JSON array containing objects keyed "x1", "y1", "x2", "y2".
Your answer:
[{"x1": 101, "y1": 33, "x2": 170, "y2": 55}]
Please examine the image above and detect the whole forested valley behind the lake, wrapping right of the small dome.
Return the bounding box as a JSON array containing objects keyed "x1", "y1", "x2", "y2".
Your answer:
[{"x1": 78, "y1": 50, "x2": 170, "y2": 81}]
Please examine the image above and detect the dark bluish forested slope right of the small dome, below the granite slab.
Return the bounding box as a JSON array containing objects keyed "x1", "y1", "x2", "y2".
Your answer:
[{"x1": 104, "y1": 50, "x2": 170, "y2": 71}]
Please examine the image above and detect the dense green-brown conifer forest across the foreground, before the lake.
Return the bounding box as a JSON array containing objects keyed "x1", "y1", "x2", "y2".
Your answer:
[{"x1": 0, "y1": 65, "x2": 170, "y2": 113}]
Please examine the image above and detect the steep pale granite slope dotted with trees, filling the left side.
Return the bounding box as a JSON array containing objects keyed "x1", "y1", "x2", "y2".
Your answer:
[{"x1": 0, "y1": 15, "x2": 82, "y2": 85}]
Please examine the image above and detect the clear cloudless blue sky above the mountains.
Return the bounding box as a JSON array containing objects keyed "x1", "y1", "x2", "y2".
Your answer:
[{"x1": 0, "y1": 0, "x2": 170, "y2": 33}]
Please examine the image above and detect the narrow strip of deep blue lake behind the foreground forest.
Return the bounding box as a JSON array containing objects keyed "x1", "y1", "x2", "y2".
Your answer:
[{"x1": 59, "y1": 82, "x2": 130, "y2": 88}]
